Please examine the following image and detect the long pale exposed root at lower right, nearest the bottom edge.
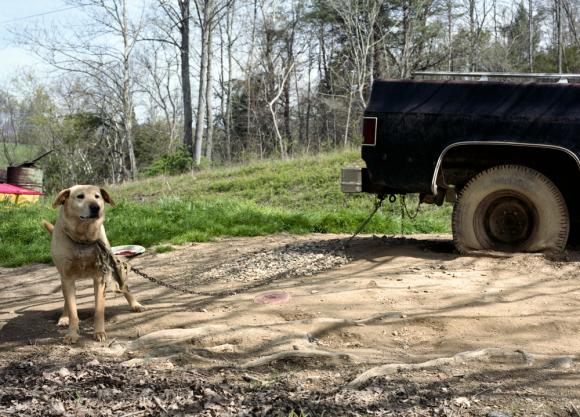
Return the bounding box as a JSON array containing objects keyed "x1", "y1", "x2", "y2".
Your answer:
[{"x1": 347, "y1": 348, "x2": 534, "y2": 389}]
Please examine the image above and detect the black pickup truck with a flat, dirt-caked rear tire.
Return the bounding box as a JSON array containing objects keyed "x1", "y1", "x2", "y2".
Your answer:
[{"x1": 342, "y1": 80, "x2": 580, "y2": 253}]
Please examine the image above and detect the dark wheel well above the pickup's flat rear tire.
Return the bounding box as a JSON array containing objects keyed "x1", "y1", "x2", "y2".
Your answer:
[{"x1": 437, "y1": 144, "x2": 580, "y2": 240}]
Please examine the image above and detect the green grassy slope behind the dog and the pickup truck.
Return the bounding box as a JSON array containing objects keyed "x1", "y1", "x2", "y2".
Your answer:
[{"x1": 0, "y1": 151, "x2": 450, "y2": 266}]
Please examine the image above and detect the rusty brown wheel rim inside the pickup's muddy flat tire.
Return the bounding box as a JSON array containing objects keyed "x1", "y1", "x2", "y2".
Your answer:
[{"x1": 474, "y1": 190, "x2": 538, "y2": 251}]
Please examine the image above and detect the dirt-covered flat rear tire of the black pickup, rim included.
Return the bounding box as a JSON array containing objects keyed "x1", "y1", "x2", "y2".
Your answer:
[{"x1": 452, "y1": 165, "x2": 570, "y2": 254}]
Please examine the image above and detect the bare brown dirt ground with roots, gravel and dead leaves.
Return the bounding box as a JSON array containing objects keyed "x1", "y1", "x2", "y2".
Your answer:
[{"x1": 0, "y1": 235, "x2": 580, "y2": 417}]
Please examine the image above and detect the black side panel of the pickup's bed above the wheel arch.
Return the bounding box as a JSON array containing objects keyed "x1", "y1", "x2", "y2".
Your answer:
[{"x1": 362, "y1": 80, "x2": 580, "y2": 193}]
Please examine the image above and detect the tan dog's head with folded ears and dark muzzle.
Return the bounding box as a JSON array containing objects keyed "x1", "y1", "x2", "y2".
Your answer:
[{"x1": 52, "y1": 185, "x2": 115, "y2": 223}]
